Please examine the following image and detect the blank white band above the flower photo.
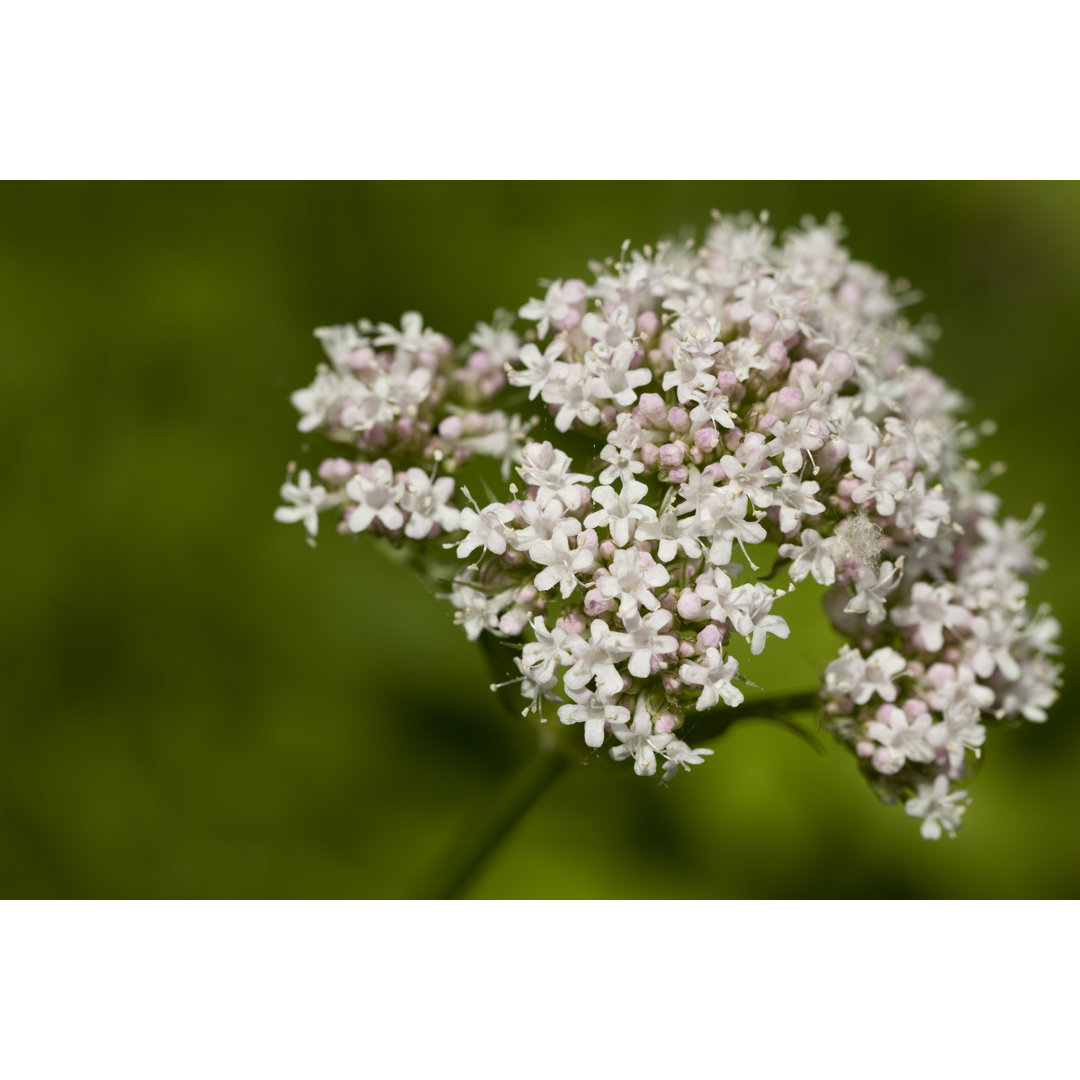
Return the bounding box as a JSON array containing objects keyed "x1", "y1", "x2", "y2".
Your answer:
[{"x1": 0, "y1": 0, "x2": 1077, "y2": 179}]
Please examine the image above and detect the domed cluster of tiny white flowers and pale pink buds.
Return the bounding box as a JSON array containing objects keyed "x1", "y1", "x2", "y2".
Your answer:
[{"x1": 276, "y1": 208, "x2": 1059, "y2": 839}]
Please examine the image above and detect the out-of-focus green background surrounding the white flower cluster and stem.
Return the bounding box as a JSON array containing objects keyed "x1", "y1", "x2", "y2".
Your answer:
[{"x1": 0, "y1": 183, "x2": 1080, "y2": 899}]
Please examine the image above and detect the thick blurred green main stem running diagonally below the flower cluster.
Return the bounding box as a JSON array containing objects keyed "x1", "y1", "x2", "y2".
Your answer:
[{"x1": 412, "y1": 748, "x2": 570, "y2": 900}]
